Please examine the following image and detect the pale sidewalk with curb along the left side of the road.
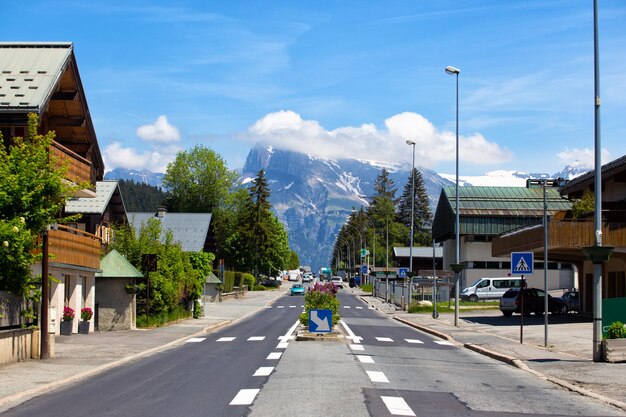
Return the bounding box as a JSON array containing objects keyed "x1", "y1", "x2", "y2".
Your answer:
[{"x1": 0, "y1": 285, "x2": 289, "y2": 413}]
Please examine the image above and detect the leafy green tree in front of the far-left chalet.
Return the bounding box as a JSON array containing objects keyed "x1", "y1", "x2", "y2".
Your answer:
[{"x1": 0, "y1": 114, "x2": 77, "y2": 295}]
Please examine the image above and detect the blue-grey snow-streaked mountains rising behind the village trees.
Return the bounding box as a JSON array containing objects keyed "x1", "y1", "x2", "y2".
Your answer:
[{"x1": 105, "y1": 147, "x2": 588, "y2": 269}]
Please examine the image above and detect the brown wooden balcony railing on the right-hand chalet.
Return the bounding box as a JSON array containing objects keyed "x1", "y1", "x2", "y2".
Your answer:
[{"x1": 492, "y1": 220, "x2": 626, "y2": 256}]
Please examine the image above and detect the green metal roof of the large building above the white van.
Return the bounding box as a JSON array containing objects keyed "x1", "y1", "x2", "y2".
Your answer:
[{"x1": 433, "y1": 186, "x2": 572, "y2": 242}]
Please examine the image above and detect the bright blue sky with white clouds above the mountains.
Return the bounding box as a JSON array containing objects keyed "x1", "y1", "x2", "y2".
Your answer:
[{"x1": 0, "y1": 0, "x2": 626, "y2": 175}]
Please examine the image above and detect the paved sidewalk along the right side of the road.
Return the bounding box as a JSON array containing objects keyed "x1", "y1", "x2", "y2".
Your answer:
[{"x1": 353, "y1": 289, "x2": 626, "y2": 415}]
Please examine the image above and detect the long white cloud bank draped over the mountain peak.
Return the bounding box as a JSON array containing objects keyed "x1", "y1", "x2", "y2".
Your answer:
[{"x1": 248, "y1": 110, "x2": 511, "y2": 167}]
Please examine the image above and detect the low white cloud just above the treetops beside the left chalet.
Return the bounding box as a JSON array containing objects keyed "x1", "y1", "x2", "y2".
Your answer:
[{"x1": 102, "y1": 142, "x2": 179, "y2": 172}]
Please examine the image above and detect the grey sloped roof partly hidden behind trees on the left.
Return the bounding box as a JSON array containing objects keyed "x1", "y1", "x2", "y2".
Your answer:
[{"x1": 127, "y1": 212, "x2": 211, "y2": 252}]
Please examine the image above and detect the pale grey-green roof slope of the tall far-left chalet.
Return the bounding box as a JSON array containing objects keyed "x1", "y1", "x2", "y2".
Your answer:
[{"x1": 0, "y1": 42, "x2": 73, "y2": 113}]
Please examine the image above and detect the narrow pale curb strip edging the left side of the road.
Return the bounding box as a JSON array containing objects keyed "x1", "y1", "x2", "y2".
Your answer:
[{"x1": 0, "y1": 293, "x2": 283, "y2": 413}]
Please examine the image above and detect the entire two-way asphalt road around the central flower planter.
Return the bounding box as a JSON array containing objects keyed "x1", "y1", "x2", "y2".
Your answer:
[{"x1": 2, "y1": 290, "x2": 623, "y2": 417}]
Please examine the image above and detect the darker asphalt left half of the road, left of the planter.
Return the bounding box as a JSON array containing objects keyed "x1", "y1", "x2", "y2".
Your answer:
[{"x1": 2, "y1": 296, "x2": 304, "y2": 417}]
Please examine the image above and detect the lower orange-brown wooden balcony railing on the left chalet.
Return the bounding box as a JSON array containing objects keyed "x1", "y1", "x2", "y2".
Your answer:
[{"x1": 48, "y1": 225, "x2": 101, "y2": 269}]
